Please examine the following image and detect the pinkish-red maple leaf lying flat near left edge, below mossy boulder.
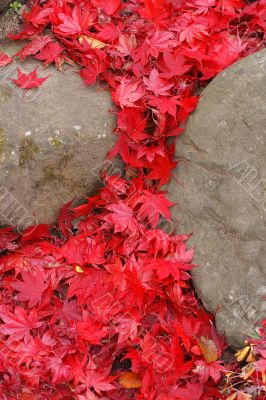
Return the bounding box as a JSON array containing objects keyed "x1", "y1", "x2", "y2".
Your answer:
[{"x1": 12, "y1": 271, "x2": 48, "y2": 308}]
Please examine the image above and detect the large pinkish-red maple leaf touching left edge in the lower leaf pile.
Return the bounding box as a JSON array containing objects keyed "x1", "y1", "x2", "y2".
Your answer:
[{"x1": 0, "y1": 306, "x2": 43, "y2": 343}]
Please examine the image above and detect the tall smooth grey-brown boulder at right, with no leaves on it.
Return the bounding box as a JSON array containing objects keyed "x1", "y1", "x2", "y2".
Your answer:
[{"x1": 169, "y1": 50, "x2": 266, "y2": 347}]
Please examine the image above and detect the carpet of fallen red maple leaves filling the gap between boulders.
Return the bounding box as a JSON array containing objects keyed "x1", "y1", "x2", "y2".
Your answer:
[{"x1": 0, "y1": 0, "x2": 266, "y2": 400}]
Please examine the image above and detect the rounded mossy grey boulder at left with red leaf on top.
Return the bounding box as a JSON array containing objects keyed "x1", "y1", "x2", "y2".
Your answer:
[{"x1": 0, "y1": 45, "x2": 118, "y2": 228}]
